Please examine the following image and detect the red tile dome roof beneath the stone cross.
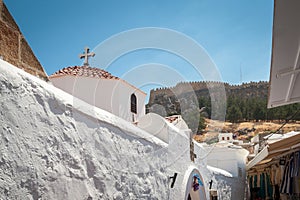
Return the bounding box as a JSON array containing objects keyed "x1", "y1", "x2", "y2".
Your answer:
[{"x1": 49, "y1": 66, "x2": 119, "y2": 80}]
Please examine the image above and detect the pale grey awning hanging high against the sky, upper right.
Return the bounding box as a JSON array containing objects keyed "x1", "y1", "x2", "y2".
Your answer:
[{"x1": 268, "y1": 0, "x2": 300, "y2": 108}]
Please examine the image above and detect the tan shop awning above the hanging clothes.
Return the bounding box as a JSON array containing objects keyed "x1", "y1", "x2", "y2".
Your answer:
[{"x1": 246, "y1": 133, "x2": 300, "y2": 170}]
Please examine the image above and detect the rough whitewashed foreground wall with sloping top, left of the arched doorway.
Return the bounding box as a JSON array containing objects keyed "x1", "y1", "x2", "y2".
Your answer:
[{"x1": 0, "y1": 60, "x2": 169, "y2": 200}]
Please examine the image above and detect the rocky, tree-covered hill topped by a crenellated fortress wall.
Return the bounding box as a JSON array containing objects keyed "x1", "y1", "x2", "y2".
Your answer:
[{"x1": 147, "y1": 81, "x2": 300, "y2": 123}]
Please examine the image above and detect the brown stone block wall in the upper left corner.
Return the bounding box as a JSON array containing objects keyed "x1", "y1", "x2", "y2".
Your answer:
[{"x1": 0, "y1": 0, "x2": 48, "y2": 81}]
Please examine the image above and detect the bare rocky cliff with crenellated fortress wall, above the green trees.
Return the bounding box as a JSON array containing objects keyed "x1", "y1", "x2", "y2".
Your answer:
[{"x1": 147, "y1": 81, "x2": 269, "y2": 115}]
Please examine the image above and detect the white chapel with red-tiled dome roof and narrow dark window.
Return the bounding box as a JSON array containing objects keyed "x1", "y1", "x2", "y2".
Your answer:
[{"x1": 49, "y1": 66, "x2": 146, "y2": 122}]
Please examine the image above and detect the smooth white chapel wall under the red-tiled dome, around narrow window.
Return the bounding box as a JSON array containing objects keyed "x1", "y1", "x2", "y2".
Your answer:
[{"x1": 50, "y1": 76, "x2": 146, "y2": 121}]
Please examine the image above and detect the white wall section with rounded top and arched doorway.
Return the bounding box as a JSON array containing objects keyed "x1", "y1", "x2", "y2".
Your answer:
[{"x1": 138, "y1": 113, "x2": 208, "y2": 200}]
